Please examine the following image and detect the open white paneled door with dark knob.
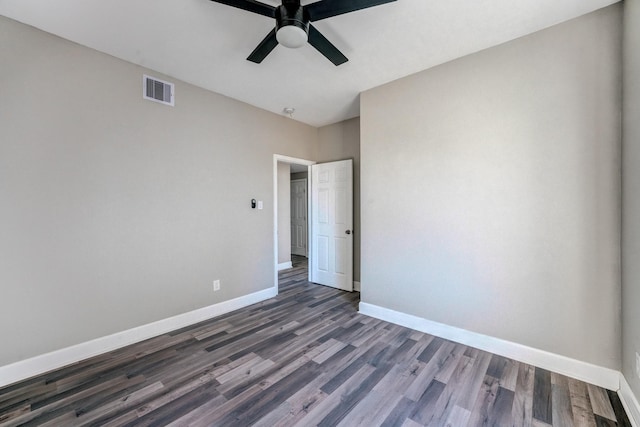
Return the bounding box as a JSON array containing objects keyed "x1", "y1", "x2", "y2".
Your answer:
[{"x1": 310, "y1": 160, "x2": 353, "y2": 291}]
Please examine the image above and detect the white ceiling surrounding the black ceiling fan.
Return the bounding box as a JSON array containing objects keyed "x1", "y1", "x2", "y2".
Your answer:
[{"x1": 0, "y1": 0, "x2": 618, "y2": 126}]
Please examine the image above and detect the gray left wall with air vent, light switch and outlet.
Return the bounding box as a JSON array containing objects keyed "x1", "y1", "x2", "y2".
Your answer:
[{"x1": 0, "y1": 17, "x2": 317, "y2": 365}]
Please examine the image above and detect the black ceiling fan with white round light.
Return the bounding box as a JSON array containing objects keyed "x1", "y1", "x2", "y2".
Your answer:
[{"x1": 211, "y1": 0, "x2": 396, "y2": 65}]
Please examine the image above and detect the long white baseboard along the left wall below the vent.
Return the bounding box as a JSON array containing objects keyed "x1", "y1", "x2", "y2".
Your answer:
[{"x1": 0, "y1": 288, "x2": 278, "y2": 387}]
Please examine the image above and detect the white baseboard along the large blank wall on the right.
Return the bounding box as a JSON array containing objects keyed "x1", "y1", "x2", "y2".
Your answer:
[{"x1": 359, "y1": 302, "x2": 620, "y2": 390}]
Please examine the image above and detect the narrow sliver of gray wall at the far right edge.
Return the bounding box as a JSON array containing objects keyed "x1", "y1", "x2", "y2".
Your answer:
[{"x1": 622, "y1": 0, "x2": 640, "y2": 398}]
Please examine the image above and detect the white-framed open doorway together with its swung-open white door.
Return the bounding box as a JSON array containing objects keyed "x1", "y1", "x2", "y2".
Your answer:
[{"x1": 273, "y1": 155, "x2": 354, "y2": 292}]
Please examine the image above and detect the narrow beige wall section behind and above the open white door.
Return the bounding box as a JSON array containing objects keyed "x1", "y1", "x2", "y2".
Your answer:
[{"x1": 315, "y1": 118, "x2": 362, "y2": 282}]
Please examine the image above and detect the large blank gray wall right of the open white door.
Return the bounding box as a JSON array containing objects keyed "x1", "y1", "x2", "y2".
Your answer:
[{"x1": 361, "y1": 5, "x2": 621, "y2": 369}]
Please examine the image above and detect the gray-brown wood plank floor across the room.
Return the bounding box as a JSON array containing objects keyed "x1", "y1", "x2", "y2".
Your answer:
[{"x1": 0, "y1": 258, "x2": 631, "y2": 427}]
